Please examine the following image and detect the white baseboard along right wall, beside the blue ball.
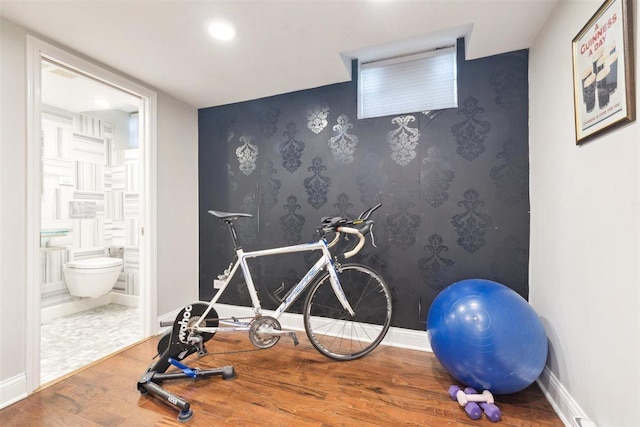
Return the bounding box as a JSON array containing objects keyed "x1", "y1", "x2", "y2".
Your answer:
[{"x1": 536, "y1": 366, "x2": 595, "y2": 427}]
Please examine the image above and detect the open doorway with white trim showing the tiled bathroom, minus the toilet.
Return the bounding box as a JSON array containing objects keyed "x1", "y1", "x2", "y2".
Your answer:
[{"x1": 27, "y1": 37, "x2": 157, "y2": 391}]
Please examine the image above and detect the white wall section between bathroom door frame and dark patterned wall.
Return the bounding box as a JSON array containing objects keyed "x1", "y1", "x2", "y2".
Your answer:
[{"x1": 157, "y1": 93, "x2": 199, "y2": 316}]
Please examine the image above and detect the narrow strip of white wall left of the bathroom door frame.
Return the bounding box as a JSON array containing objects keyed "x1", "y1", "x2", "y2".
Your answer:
[{"x1": 0, "y1": 20, "x2": 27, "y2": 404}]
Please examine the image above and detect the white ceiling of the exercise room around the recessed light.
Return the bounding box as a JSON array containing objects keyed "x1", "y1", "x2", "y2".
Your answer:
[{"x1": 0, "y1": 0, "x2": 559, "y2": 108}]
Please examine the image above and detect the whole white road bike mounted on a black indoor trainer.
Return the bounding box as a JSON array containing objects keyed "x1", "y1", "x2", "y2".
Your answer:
[{"x1": 138, "y1": 204, "x2": 392, "y2": 421}]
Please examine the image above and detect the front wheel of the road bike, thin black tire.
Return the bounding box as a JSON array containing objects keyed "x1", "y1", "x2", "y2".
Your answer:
[{"x1": 304, "y1": 264, "x2": 391, "y2": 360}]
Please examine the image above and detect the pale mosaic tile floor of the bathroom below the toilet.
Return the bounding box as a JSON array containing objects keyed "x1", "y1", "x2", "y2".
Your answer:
[{"x1": 40, "y1": 304, "x2": 142, "y2": 384}]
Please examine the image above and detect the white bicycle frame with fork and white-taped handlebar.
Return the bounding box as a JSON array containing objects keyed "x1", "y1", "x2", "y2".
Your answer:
[{"x1": 189, "y1": 227, "x2": 365, "y2": 333}]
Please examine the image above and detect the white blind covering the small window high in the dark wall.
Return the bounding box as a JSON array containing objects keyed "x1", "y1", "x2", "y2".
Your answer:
[{"x1": 358, "y1": 47, "x2": 458, "y2": 119}]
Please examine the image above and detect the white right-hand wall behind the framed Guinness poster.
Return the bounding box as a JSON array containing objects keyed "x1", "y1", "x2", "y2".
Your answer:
[{"x1": 529, "y1": 0, "x2": 640, "y2": 426}]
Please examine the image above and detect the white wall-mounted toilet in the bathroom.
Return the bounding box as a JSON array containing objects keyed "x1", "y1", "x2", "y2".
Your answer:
[{"x1": 62, "y1": 257, "x2": 123, "y2": 298}]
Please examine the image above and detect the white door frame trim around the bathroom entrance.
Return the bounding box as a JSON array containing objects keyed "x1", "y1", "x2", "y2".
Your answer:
[{"x1": 26, "y1": 35, "x2": 158, "y2": 394}]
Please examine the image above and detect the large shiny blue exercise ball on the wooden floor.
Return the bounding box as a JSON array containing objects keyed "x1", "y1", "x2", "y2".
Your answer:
[{"x1": 427, "y1": 279, "x2": 547, "y2": 394}]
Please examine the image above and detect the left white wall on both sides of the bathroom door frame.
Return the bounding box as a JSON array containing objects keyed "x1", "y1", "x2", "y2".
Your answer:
[{"x1": 0, "y1": 15, "x2": 198, "y2": 407}]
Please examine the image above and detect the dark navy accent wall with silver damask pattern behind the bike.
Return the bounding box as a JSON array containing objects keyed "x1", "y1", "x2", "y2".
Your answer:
[{"x1": 198, "y1": 42, "x2": 529, "y2": 330}]
